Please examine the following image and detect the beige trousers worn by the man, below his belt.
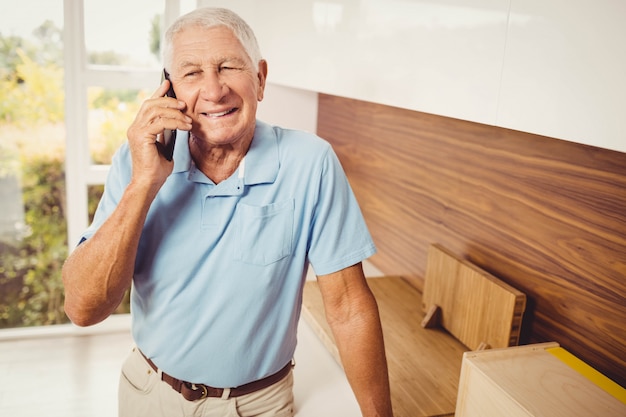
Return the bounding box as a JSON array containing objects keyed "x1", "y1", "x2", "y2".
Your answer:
[{"x1": 118, "y1": 348, "x2": 294, "y2": 417}]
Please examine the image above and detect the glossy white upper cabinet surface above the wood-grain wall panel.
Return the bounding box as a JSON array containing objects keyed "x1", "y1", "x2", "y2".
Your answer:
[{"x1": 199, "y1": 0, "x2": 626, "y2": 152}]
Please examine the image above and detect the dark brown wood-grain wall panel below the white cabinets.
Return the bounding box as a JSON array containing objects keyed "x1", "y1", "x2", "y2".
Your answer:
[{"x1": 318, "y1": 95, "x2": 626, "y2": 386}]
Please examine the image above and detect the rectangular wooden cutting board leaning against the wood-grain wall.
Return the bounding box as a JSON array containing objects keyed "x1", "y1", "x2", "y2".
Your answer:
[{"x1": 422, "y1": 244, "x2": 526, "y2": 350}]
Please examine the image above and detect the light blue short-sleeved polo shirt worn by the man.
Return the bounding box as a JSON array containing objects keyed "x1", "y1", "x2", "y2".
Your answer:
[{"x1": 84, "y1": 121, "x2": 375, "y2": 387}]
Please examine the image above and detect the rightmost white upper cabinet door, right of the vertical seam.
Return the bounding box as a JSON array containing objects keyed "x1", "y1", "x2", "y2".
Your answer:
[{"x1": 497, "y1": 0, "x2": 626, "y2": 152}]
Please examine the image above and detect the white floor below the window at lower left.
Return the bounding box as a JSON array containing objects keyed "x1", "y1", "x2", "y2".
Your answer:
[{"x1": 0, "y1": 317, "x2": 131, "y2": 417}]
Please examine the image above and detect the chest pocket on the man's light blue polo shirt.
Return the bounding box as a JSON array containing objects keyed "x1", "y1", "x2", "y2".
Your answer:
[{"x1": 235, "y1": 200, "x2": 295, "y2": 265}]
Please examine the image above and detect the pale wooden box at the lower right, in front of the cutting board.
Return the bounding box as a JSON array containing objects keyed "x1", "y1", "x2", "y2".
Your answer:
[{"x1": 455, "y1": 343, "x2": 626, "y2": 417}]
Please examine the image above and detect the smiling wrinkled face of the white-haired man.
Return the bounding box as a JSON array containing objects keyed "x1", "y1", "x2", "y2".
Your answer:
[{"x1": 170, "y1": 26, "x2": 267, "y2": 147}]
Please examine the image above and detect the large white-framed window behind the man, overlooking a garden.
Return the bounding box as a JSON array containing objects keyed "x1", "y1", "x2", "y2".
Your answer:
[{"x1": 0, "y1": 0, "x2": 195, "y2": 328}]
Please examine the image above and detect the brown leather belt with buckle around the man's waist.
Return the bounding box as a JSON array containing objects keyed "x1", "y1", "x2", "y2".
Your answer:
[{"x1": 139, "y1": 350, "x2": 293, "y2": 401}]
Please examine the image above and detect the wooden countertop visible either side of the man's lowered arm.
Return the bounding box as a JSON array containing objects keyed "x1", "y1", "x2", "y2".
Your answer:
[{"x1": 303, "y1": 277, "x2": 467, "y2": 417}]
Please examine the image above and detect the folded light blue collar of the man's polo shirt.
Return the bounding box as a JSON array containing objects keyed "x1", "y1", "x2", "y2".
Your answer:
[{"x1": 172, "y1": 120, "x2": 280, "y2": 185}]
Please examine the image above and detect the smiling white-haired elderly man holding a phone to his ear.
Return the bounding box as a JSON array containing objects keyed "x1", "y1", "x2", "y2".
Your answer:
[{"x1": 63, "y1": 8, "x2": 391, "y2": 417}]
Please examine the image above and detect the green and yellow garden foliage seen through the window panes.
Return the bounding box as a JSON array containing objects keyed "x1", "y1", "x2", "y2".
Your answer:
[{"x1": 0, "y1": 17, "x2": 158, "y2": 328}]
